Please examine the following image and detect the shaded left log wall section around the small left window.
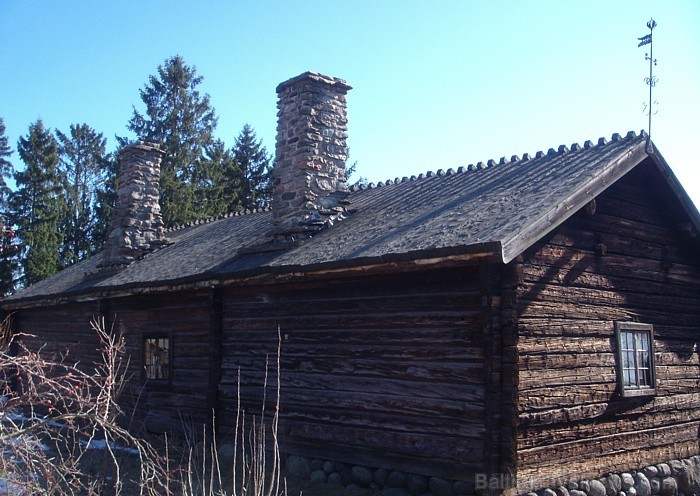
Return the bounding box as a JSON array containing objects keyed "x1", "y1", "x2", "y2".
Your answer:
[{"x1": 14, "y1": 291, "x2": 216, "y2": 429}]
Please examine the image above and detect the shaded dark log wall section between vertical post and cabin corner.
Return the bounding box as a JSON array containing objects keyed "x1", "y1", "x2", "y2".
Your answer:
[{"x1": 219, "y1": 267, "x2": 485, "y2": 478}]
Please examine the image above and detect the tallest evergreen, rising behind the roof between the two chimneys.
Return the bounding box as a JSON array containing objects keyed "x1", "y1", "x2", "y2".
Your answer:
[{"x1": 127, "y1": 55, "x2": 217, "y2": 226}]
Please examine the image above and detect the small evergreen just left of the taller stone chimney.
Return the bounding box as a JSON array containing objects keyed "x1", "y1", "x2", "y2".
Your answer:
[{"x1": 233, "y1": 124, "x2": 272, "y2": 209}]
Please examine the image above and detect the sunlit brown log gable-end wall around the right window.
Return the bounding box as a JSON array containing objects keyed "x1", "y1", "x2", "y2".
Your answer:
[{"x1": 517, "y1": 165, "x2": 700, "y2": 491}]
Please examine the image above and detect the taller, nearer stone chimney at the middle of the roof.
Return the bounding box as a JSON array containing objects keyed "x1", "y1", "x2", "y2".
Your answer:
[{"x1": 272, "y1": 72, "x2": 352, "y2": 243}]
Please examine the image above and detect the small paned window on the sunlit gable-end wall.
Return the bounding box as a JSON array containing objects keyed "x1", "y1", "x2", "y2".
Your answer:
[{"x1": 615, "y1": 322, "x2": 656, "y2": 397}]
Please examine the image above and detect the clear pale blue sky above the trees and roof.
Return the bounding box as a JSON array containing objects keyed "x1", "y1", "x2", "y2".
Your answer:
[{"x1": 0, "y1": 0, "x2": 700, "y2": 205}]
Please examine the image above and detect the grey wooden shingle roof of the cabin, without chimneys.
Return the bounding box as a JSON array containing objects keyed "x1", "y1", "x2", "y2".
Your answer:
[{"x1": 2, "y1": 132, "x2": 700, "y2": 308}]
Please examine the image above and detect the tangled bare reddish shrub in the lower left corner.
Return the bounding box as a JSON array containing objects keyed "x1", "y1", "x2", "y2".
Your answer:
[{"x1": 0, "y1": 318, "x2": 168, "y2": 495}]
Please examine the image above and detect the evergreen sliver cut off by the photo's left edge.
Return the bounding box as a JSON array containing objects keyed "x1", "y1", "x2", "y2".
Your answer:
[{"x1": 0, "y1": 117, "x2": 16, "y2": 295}]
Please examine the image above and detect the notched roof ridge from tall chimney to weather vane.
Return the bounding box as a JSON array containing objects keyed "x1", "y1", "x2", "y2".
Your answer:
[{"x1": 348, "y1": 129, "x2": 649, "y2": 192}]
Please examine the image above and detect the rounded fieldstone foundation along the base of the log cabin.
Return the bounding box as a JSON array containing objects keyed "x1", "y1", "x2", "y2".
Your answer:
[{"x1": 278, "y1": 456, "x2": 700, "y2": 496}]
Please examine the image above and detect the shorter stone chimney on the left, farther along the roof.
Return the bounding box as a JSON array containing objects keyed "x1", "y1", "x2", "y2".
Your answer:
[{"x1": 101, "y1": 143, "x2": 167, "y2": 270}]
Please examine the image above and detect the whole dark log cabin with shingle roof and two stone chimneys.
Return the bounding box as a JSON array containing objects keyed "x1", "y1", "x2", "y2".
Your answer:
[{"x1": 0, "y1": 72, "x2": 700, "y2": 493}]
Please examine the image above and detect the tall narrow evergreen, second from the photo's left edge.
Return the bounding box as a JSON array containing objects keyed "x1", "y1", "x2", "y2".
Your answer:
[{"x1": 10, "y1": 120, "x2": 66, "y2": 285}]
